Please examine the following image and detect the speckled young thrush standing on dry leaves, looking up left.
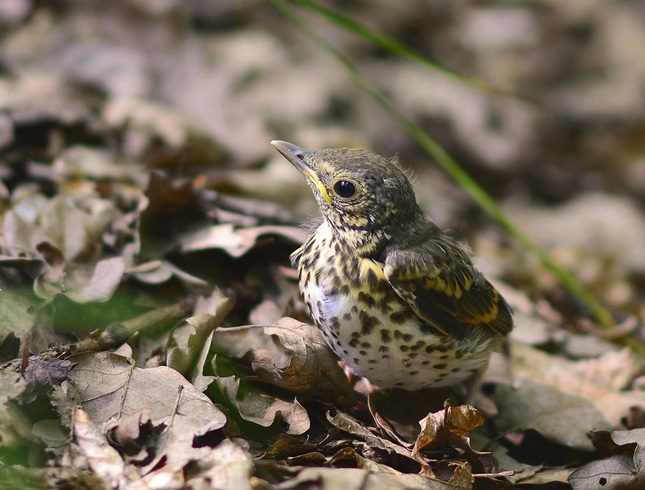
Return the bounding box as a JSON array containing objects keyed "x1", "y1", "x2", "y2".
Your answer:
[{"x1": 271, "y1": 140, "x2": 513, "y2": 400}]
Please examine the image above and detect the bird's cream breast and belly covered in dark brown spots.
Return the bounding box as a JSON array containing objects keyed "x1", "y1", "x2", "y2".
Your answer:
[{"x1": 292, "y1": 225, "x2": 500, "y2": 390}]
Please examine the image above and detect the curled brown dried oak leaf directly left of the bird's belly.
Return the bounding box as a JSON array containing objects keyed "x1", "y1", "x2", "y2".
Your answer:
[{"x1": 213, "y1": 318, "x2": 354, "y2": 406}]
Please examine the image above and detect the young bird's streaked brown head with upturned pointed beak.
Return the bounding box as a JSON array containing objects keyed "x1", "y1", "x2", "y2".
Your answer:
[{"x1": 271, "y1": 141, "x2": 423, "y2": 253}]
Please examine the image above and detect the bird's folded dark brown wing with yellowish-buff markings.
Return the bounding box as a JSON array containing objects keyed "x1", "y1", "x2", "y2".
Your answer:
[{"x1": 384, "y1": 239, "x2": 513, "y2": 338}]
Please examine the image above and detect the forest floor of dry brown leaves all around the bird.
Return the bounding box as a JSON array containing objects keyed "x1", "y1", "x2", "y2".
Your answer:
[{"x1": 0, "y1": 0, "x2": 645, "y2": 490}]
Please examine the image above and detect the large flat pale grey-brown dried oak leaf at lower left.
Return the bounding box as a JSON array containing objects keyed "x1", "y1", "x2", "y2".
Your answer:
[{"x1": 52, "y1": 352, "x2": 226, "y2": 474}]
